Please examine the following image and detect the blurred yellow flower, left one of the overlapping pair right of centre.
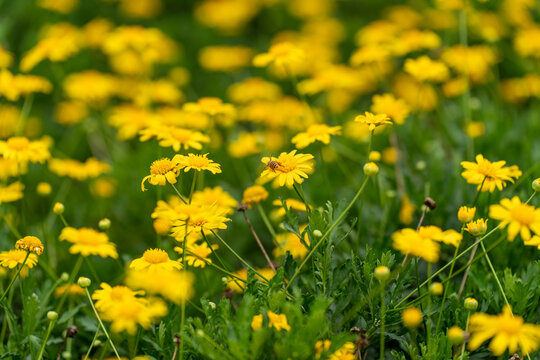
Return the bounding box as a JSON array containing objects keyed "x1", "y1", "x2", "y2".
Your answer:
[{"x1": 392, "y1": 229, "x2": 439, "y2": 262}]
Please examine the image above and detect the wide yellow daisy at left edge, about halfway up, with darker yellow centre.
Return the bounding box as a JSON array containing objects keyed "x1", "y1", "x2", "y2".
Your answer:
[{"x1": 0, "y1": 136, "x2": 51, "y2": 163}]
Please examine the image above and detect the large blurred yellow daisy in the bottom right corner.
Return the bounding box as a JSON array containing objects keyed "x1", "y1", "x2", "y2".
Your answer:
[{"x1": 469, "y1": 305, "x2": 540, "y2": 356}]
